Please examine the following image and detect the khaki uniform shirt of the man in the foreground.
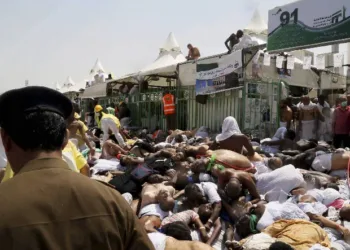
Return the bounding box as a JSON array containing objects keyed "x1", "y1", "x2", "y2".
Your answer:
[{"x1": 0, "y1": 158, "x2": 154, "y2": 250}]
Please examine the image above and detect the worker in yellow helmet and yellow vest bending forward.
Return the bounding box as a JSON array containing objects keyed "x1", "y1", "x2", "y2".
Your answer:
[{"x1": 94, "y1": 105, "x2": 126, "y2": 148}]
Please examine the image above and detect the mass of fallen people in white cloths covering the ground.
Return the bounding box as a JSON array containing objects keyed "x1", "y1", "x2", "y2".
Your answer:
[{"x1": 84, "y1": 117, "x2": 350, "y2": 250}]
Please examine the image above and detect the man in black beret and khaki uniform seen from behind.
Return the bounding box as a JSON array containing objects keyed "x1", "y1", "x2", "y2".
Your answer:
[{"x1": 0, "y1": 86, "x2": 154, "y2": 250}]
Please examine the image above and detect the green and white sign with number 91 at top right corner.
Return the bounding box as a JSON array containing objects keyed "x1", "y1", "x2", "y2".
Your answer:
[{"x1": 267, "y1": 0, "x2": 350, "y2": 52}]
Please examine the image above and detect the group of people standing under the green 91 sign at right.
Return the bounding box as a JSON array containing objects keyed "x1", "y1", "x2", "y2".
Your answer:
[{"x1": 280, "y1": 95, "x2": 350, "y2": 148}]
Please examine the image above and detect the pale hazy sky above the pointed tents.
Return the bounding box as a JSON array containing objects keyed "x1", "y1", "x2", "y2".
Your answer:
[{"x1": 0, "y1": 0, "x2": 346, "y2": 92}]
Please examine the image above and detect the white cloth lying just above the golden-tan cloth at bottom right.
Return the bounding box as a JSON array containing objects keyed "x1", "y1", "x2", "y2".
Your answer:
[{"x1": 256, "y1": 202, "x2": 310, "y2": 231}]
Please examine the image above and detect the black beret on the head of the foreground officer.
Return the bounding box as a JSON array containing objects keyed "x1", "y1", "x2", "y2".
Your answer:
[{"x1": 0, "y1": 86, "x2": 73, "y2": 125}]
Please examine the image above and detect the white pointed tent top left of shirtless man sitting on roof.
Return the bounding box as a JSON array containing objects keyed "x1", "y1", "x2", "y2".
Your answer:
[{"x1": 139, "y1": 32, "x2": 186, "y2": 77}]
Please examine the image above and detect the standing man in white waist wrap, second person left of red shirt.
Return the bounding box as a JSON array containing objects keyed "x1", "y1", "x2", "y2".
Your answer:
[{"x1": 299, "y1": 96, "x2": 319, "y2": 140}]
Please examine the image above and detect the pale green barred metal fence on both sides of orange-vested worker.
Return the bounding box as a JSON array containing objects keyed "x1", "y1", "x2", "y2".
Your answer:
[{"x1": 81, "y1": 86, "x2": 243, "y2": 132}]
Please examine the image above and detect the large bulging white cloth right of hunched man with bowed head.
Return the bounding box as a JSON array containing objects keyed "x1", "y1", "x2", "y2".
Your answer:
[{"x1": 256, "y1": 165, "x2": 305, "y2": 202}]
